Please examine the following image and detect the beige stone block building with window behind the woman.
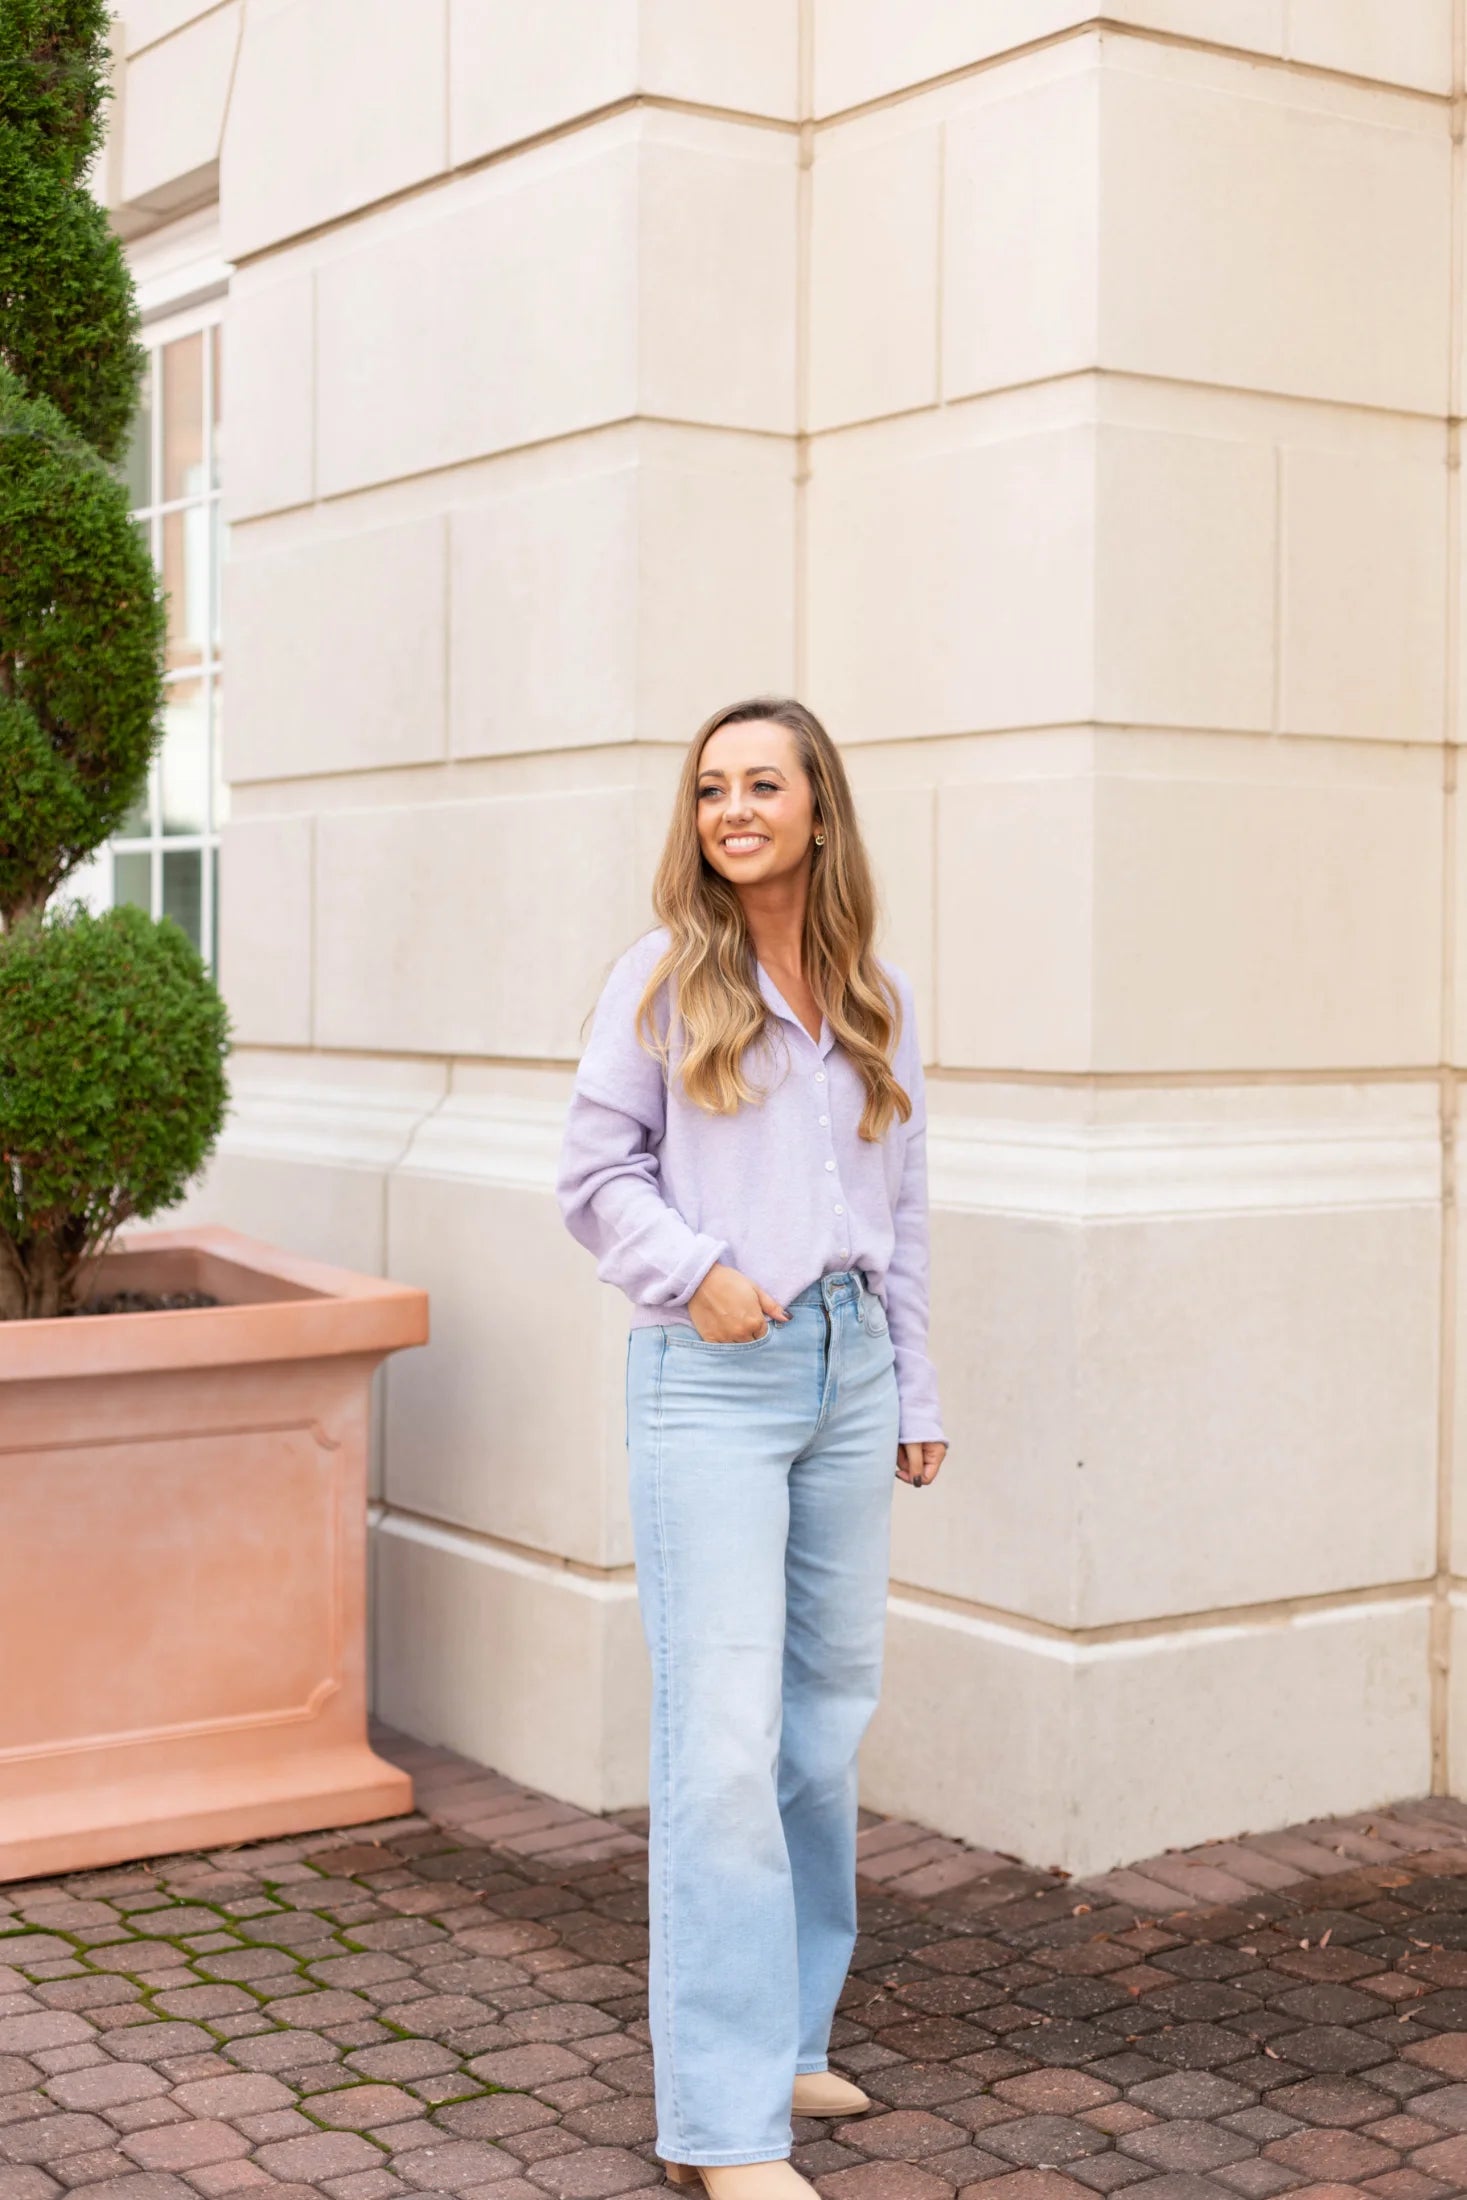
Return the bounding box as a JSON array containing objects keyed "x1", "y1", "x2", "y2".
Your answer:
[{"x1": 92, "y1": 0, "x2": 1467, "y2": 1870}]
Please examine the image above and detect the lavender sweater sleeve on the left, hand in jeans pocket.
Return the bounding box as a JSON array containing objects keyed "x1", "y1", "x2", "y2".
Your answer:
[{"x1": 556, "y1": 942, "x2": 728, "y2": 1307}]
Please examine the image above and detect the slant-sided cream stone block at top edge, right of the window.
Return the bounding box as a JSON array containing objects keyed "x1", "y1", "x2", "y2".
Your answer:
[{"x1": 220, "y1": 0, "x2": 449, "y2": 260}]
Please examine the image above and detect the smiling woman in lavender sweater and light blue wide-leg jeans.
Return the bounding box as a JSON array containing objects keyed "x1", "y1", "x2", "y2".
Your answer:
[{"x1": 556, "y1": 700, "x2": 946, "y2": 2200}]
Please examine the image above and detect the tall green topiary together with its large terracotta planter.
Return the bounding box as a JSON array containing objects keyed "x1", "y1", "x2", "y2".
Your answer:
[{"x1": 0, "y1": 0, "x2": 427, "y2": 1879}]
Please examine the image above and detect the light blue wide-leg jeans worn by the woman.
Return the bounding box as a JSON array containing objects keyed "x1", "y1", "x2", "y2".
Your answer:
[{"x1": 627, "y1": 1269, "x2": 897, "y2": 2163}]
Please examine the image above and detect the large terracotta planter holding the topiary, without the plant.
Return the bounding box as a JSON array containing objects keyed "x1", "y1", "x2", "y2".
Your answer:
[{"x1": 0, "y1": 1230, "x2": 427, "y2": 1879}]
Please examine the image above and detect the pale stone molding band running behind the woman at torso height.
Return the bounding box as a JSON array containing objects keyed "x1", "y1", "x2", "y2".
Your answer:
[{"x1": 220, "y1": 1080, "x2": 1441, "y2": 1223}]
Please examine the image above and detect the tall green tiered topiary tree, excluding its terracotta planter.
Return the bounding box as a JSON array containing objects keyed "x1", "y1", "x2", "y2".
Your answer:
[{"x1": 0, "y1": 0, "x2": 229, "y2": 1320}]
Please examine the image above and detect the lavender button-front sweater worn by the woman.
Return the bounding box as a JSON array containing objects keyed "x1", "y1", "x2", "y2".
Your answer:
[{"x1": 556, "y1": 926, "x2": 941, "y2": 1443}]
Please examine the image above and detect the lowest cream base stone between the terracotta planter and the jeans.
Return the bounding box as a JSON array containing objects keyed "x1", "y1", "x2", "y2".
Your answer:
[{"x1": 374, "y1": 1511, "x2": 649, "y2": 1811}]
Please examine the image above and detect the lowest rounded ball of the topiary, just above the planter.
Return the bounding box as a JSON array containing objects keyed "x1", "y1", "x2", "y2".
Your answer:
[{"x1": 0, "y1": 906, "x2": 227, "y2": 1318}]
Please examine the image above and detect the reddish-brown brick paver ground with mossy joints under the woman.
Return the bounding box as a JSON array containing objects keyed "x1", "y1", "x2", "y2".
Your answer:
[{"x1": 0, "y1": 1745, "x2": 1467, "y2": 2200}]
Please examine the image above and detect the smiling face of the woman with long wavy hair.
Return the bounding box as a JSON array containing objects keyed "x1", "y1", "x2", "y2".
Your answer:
[{"x1": 697, "y1": 717, "x2": 818, "y2": 887}]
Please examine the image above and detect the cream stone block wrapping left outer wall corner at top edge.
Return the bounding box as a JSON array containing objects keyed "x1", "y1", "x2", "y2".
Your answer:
[{"x1": 449, "y1": 0, "x2": 798, "y2": 165}]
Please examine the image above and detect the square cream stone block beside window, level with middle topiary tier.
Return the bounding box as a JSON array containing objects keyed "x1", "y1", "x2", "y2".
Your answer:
[{"x1": 227, "y1": 519, "x2": 449, "y2": 779}]
